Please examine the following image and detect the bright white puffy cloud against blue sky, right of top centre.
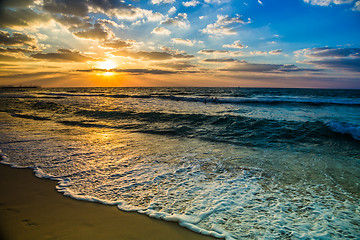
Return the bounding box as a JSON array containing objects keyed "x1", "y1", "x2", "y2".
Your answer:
[{"x1": 200, "y1": 14, "x2": 245, "y2": 36}]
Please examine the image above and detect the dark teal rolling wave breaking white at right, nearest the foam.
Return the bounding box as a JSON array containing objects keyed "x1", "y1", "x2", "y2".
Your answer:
[{"x1": 72, "y1": 110, "x2": 360, "y2": 147}]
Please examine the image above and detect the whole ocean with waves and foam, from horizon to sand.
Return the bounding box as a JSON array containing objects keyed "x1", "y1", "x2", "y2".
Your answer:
[{"x1": 0, "y1": 88, "x2": 360, "y2": 240}]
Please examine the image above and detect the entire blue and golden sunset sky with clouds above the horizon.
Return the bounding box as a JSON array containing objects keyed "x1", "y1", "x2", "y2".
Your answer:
[{"x1": 0, "y1": 0, "x2": 360, "y2": 89}]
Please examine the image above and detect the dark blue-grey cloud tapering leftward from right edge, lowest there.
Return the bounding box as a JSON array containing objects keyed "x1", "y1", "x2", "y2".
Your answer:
[{"x1": 305, "y1": 58, "x2": 360, "y2": 72}]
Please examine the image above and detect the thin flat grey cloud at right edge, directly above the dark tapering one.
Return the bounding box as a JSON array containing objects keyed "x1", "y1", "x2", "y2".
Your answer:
[{"x1": 308, "y1": 47, "x2": 360, "y2": 58}]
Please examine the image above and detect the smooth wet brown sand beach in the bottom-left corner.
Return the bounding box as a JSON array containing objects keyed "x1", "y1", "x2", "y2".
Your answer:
[{"x1": 0, "y1": 165, "x2": 212, "y2": 240}]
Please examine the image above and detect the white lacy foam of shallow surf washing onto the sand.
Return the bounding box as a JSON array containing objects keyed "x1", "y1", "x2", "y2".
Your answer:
[{"x1": 1, "y1": 146, "x2": 360, "y2": 240}]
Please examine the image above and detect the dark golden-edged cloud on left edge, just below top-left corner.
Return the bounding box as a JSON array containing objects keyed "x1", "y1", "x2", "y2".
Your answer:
[{"x1": 0, "y1": 8, "x2": 49, "y2": 28}]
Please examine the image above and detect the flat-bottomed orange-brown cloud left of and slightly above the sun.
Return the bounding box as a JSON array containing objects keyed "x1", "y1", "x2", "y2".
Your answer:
[{"x1": 31, "y1": 49, "x2": 96, "y2": 62}]
